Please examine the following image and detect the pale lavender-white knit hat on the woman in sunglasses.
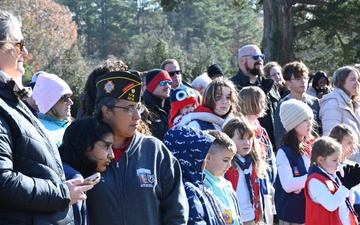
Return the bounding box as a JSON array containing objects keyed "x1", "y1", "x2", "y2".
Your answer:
[{"x1": 33, "y1": 72, "x2": 72, "y2": 113}]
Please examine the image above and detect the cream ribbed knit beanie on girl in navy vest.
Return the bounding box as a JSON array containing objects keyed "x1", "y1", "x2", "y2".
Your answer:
[{"x1": 280, "y1": 99, "x2": 314, "y2": 131}]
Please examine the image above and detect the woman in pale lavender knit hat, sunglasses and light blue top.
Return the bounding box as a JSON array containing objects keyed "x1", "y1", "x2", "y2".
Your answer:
[{"x1": 33, "y1": 72, "x2": 74, "y2": 147}]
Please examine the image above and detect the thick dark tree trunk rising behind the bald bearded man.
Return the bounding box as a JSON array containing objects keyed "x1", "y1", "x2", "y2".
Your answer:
[{"x1": 263, "y1": 0, "x2": 295, "y2": 65}]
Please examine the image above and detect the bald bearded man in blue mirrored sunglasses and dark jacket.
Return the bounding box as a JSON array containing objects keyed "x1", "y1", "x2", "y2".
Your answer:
[{"x1": 230, "y1": 45, "x2": 281, "y2": 147}]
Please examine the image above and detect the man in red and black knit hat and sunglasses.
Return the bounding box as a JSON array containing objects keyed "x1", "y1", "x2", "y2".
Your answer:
[{"x1": 141, "y1": 69, "x2": 173, "y2": 140}]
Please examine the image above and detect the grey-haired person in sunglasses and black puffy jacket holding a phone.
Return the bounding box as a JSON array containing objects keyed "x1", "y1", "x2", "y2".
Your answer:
[{"x1": 0, "y1": 10, "x2": 93, "y2": 224}]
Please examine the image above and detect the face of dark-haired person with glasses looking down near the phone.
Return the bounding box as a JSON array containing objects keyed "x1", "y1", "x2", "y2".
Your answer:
[{"x1": 86, "y1": 133, "x2": 114, "y2": 172}]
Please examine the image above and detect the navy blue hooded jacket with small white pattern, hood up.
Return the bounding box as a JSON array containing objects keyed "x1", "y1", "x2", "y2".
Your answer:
[{"x1": 164, "y1": 126, "x2": 225, "y2": 225}]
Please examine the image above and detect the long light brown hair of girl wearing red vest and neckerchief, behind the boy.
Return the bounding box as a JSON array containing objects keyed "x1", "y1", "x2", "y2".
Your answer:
[{"x1": 222, "y1": 117, "x2": 268, "y2": 178}]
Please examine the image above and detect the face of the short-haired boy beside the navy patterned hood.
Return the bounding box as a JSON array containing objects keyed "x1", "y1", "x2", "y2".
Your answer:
[{"x1": 206, "y1": 148, "x2": 234, "y2": 177}]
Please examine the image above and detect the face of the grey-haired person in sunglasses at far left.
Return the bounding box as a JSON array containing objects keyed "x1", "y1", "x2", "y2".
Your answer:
[{"x1": 0, "y1": 27, "x2": 28, "y2": 79}]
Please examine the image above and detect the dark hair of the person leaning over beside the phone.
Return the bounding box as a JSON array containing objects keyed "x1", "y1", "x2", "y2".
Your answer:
[{"x1": 59, "y1": 117, "x2": 113, "y2": 177}]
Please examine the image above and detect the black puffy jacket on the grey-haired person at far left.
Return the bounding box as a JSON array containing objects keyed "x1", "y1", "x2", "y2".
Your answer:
[{"x1": 0, "y1": 82, "x2": 73, "y2": 225}]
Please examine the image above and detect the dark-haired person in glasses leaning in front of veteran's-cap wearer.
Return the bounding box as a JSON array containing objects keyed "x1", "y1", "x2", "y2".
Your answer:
[{"x1": 59, "y1": 117, "x2": 114, "y2": 225}]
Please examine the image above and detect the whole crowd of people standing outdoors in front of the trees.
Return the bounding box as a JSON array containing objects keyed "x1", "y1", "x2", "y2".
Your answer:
[{"x1": 0, "y1": 10, "x2": 360, "y2": 225}]
